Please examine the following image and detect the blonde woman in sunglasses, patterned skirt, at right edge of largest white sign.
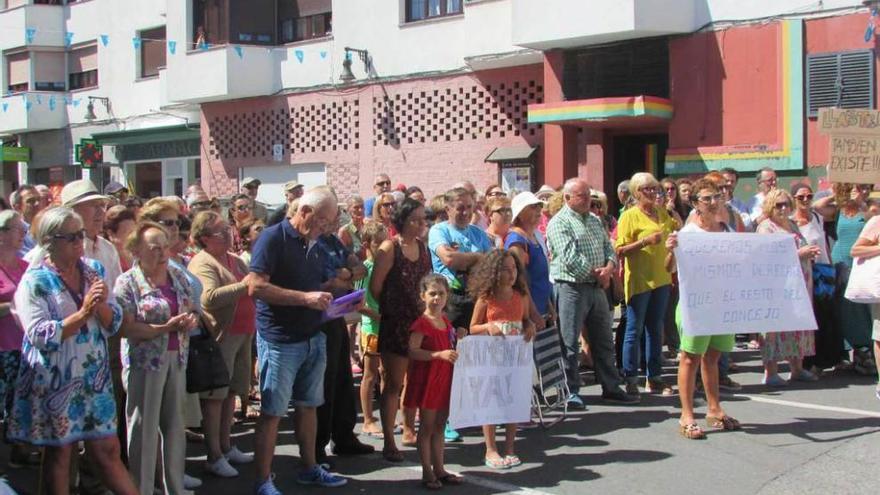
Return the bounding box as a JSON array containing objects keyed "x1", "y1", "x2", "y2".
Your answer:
[{"x1": 757, "y1": 189, "x2": 820, "y2": 387}]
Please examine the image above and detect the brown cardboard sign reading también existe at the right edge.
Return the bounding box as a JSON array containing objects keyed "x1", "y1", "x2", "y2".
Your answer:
[{"x1": 818, "y1": 108, "x2": 880, "y2": 184}]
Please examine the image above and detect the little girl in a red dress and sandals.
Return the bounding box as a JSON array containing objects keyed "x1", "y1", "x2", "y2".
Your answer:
[{"x1": 403, "y1": 274, "x2": 464, "y2": 490}]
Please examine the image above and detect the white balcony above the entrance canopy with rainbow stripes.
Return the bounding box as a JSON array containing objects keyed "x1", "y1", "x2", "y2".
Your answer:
[{"x1": 512, "y1": 0, "x2": 705, "y2": 50}]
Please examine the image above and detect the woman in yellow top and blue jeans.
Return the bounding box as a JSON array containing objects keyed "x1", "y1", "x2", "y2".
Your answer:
[{"x1": 615, "y1": 172, "x2": 676, "y2": 395}]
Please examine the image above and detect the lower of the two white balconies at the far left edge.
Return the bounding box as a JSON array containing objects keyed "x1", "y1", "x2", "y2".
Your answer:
[{"x1": 0, "y1": 92, "x2": 67, "y2": 135}]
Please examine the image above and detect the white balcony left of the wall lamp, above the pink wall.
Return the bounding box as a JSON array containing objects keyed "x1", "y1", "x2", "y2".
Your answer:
[{"x1": 160, "y1": 45, "x2": 280, "y2": 103}]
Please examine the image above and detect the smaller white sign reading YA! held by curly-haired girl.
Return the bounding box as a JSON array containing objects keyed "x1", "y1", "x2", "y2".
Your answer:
[{"x1": 449, "y1": 335, "x2": 534, "y2": 428}]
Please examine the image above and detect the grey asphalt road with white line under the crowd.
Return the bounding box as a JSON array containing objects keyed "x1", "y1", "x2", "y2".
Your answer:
[{"x1": 0, "y1": 344, "x2": 880, "y2": 495}]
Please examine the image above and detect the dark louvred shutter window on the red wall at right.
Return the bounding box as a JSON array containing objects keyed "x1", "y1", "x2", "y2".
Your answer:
[{"x1": 807, "y1": 50, "x2": 874, "y2": 117}]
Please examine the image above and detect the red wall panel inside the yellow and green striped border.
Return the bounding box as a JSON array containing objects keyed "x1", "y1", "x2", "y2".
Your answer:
[{"x1": 669, "y1": 23, "x2": 781, "y2": 149}]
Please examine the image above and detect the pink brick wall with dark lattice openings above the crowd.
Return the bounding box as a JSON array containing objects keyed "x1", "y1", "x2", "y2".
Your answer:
[{"x1": 202, "y1": 65, "x2": 543, "y2": 201}]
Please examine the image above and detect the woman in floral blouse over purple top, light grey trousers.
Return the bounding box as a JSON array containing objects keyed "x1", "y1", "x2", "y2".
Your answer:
[{"x1": 114, "y1": 221, "x2": 198, "y2": 493}]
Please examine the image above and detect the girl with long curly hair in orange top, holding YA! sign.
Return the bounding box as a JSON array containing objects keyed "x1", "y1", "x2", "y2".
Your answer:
[{"x1": 468, "y1": 249, "x2": 535, "y2": 469}]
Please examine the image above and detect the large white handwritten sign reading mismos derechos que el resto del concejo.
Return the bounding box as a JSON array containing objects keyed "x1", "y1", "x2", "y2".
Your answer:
[{"x1": 675, "y1": 232, "x2": 816, "y2": 335}]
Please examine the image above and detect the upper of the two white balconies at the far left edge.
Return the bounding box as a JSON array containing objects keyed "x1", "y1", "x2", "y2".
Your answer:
[{"x1": 0, "y1": 1, "x2": 64, "y2": 49}]
